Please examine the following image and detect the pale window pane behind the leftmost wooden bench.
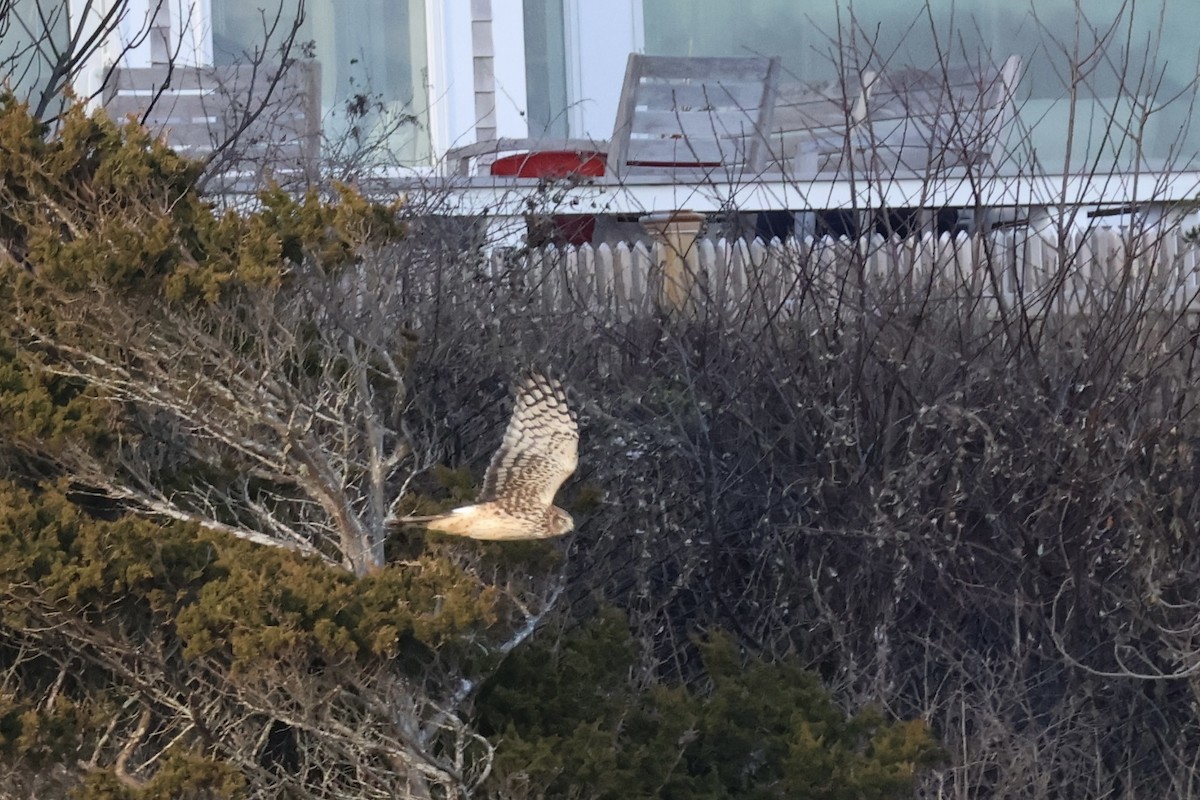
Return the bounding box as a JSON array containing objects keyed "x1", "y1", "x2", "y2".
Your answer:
[{"x1": 212, "y1": 0, "x2": 430, "y2": 166}]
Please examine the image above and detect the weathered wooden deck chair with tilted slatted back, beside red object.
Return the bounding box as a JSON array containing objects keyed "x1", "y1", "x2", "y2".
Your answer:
[{"x1": 445, "y1": 53, "x2": 779, "y2": 180}]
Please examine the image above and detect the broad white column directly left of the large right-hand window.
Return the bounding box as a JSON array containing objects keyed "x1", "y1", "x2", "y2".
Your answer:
[{"x1": 563, "y1": 0, "x2": 646, "y2": 139}]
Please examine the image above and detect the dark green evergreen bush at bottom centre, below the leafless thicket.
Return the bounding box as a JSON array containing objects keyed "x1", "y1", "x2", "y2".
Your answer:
[{"x1": 480, "y1": 610, "x2": 941, "y2": 800}]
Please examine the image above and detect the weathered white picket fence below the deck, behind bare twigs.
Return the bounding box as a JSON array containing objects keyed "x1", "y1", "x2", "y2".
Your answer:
[{"x1": 463, "y1": 229, "x2": 1200, "y2": 320}]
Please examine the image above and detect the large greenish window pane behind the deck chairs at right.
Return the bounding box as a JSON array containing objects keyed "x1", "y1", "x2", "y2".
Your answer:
[{"x1": 643, "y1": 0, "x2": 1200, "y2": 173}]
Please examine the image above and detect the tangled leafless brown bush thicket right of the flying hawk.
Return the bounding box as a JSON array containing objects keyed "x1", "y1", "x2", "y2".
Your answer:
[{"x1": 384, "y1": 5, "x2": 1200, "y2": 798}]
